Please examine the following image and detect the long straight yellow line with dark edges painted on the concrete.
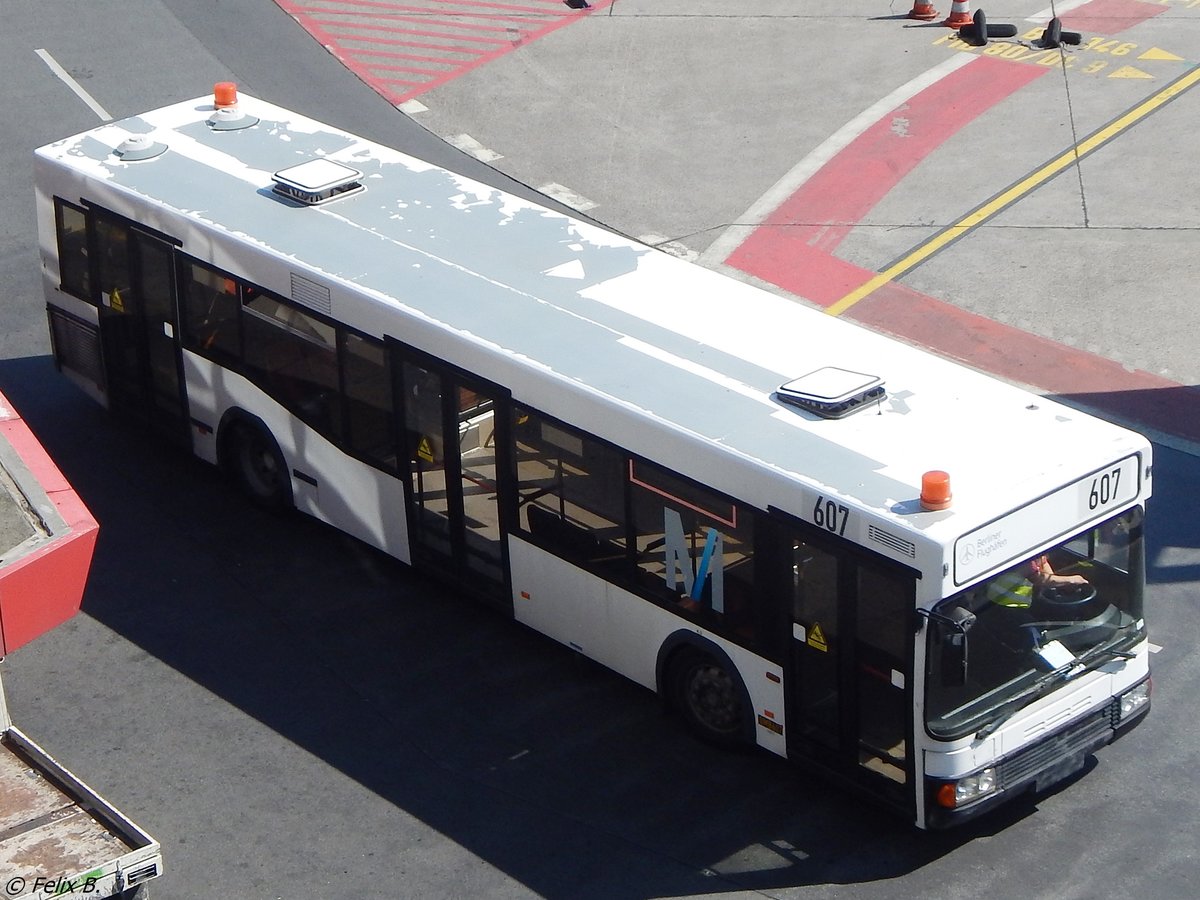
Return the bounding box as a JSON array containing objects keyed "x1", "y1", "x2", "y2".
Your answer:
[{"x1": 826, "y1": 67, "x2": 1200, "y2": 316}]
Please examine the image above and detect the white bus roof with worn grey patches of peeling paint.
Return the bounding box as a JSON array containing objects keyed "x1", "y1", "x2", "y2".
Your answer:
[{"x1": 38, "y1": 95, "x2": 1148, "y2": 571}]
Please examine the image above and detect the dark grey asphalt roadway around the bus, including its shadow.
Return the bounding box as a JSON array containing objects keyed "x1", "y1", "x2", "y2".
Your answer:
[{"x1": 0, "y1": 0, "x2": 1200, "y2": 900}]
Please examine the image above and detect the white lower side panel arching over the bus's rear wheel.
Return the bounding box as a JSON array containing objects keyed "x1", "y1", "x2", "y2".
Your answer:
[{"x1": 184, "y1": 350, "x2": 412, "y2": 563}]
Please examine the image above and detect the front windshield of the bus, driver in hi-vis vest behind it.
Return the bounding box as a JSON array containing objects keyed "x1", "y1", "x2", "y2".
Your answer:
[{"x1": 925, "y1": 508, "x2": 1146, "y2": 739}]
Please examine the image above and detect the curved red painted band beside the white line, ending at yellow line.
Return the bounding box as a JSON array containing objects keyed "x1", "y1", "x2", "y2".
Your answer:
[{"x1": 726, "y1": 56, "x2": 1049, "y2": 306}]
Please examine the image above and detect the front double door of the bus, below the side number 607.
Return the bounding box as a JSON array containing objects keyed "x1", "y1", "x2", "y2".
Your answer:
[{"x1": 784, "y1": 524, "x2": 914, "y2": 809}]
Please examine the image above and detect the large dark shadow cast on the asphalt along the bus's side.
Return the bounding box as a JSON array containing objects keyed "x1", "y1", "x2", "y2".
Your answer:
[{"x1": 0, "y1": 358, "x2": 1132, "y2": 899}]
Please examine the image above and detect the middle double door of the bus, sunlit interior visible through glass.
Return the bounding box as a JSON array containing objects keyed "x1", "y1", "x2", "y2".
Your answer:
[{"x1": 396, "y1": 350, "x2": 511, "y2": 606}]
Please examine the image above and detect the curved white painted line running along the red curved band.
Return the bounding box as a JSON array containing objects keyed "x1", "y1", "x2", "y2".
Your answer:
[{"x1": 700, "y1": 53, "x2": 976, "y2": 269}]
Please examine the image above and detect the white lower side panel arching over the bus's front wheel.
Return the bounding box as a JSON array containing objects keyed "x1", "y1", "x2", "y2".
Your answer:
[{"x1": 509, "y1": 538, "x2": 787, "y2": 756}]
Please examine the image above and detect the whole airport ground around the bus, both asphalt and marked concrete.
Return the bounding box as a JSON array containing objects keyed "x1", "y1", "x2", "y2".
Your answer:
[{"x1": 0, "y1": 0, "x2": 1200, "y2": 900}]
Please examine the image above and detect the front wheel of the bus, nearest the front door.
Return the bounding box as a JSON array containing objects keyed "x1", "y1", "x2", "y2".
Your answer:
[{"x1": 671, "y1": 648, "x2": 750, "y2": 748}]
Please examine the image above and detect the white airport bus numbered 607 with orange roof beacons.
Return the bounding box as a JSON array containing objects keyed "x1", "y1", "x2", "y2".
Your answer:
[{"x1": 36, "y1": 84, "x2": 1151, "y2": 828}]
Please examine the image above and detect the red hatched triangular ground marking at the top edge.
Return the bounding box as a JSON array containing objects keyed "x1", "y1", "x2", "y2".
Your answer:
[{"x1": 275, "y1": 0, "x2": 614, "y2": 106}]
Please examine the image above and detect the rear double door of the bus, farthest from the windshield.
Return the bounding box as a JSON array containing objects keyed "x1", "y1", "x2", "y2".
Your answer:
[{"x1": 92, "y1": 211, "x2": 190, "y2": 444}]
